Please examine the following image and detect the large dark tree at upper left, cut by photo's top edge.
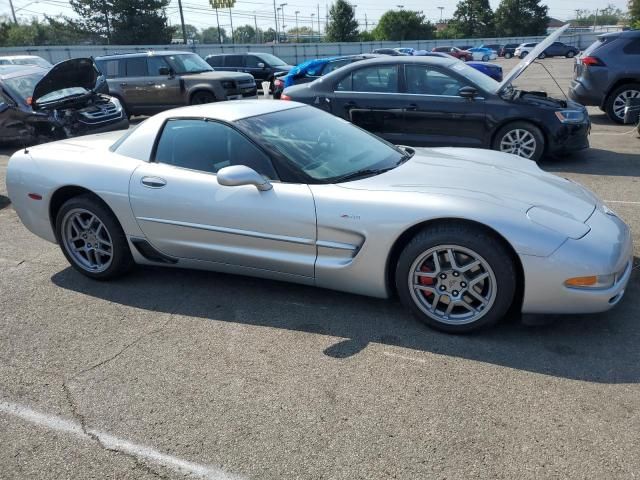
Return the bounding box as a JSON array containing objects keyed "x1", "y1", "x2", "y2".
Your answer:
[{"x1": 69, "y1": 0, "x2": 175, "y2": 45}]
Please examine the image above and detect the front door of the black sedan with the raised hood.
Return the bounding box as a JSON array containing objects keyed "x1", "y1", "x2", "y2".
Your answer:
[{"x1": 404, "y1": 64, "x2": 485, "y2": 147}]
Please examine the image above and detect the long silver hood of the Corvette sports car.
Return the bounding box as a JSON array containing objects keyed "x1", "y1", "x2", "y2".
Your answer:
[{"x1": 340, "y1": 147, "x2": 599, "y2": 222}]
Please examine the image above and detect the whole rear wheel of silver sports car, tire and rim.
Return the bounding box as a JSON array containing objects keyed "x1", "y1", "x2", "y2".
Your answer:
[{"x1": 56, "y1": 194, "x2": 133, "y2": 280}]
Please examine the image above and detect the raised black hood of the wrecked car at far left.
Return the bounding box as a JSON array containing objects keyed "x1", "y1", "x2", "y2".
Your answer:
[{"x1": 32, "y1": 58, "x2": 100, "y2": 106}]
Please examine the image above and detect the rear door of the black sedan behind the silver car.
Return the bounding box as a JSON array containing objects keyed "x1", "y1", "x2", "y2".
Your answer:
[{"x1": 330, "y1": 64, "x2": 406, "y2": 142}]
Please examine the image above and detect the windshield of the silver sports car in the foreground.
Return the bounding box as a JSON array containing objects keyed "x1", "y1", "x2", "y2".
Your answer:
[{"x1": 237, "y1": 107, "x2": 406, "y2": 183}]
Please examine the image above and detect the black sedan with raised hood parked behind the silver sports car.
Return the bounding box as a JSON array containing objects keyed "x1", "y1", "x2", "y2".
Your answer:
[{"x1": 282, "y1": 55, "x2": 590, "y2": 161}]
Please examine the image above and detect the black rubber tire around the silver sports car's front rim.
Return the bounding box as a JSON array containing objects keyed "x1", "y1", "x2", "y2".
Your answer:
[{"x1": 396, "y1": 223, "x2": 516, "y2": 333}]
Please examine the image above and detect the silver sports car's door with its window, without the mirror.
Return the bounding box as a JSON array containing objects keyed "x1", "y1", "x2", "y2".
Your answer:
[{"x1": 129, "y1": 119, "x2": 316, "y2": 278}]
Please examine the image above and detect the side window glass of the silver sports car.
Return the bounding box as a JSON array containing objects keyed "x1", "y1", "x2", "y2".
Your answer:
[{"x1": 155, "y1": 119, "x2": 277, "y2": 180}]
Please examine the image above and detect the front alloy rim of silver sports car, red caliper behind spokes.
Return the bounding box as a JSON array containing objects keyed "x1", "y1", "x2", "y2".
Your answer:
[{"x1": 408, "y1": 245, "x2": 497, "y2": 325}]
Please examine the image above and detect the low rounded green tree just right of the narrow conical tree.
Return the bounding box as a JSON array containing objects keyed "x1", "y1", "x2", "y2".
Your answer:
[{"x1": 371, "y1": 10, "x2": 435, "y2": 40}]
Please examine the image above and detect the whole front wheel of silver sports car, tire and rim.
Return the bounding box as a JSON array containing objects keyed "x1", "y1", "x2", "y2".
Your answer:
[{"x1": 396, "y1": 224, "x2": 516, "y2": 333}]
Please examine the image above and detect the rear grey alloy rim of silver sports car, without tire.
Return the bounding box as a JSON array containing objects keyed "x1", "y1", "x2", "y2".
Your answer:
[{"x1": 62, "y1": 208, "x2": 113, "y2": 273}]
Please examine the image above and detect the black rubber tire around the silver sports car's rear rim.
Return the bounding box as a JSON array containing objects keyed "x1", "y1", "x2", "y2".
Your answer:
[{"x1": 56, "y1": 194, "x2": 134, "y2": 280}]
